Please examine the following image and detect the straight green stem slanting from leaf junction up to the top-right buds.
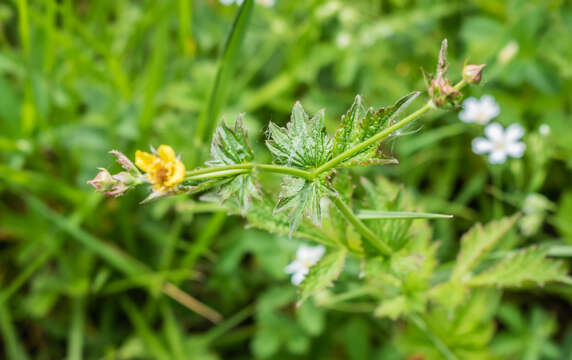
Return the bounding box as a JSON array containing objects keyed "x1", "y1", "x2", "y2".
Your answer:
[{"x1": 310, "y1": 80, "x2": 466, "y2": 178}]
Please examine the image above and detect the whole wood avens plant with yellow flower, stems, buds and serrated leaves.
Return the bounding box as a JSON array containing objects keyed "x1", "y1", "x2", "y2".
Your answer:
[{"x1": 90, "y1": 41, "x2": 569, "y2": 358}]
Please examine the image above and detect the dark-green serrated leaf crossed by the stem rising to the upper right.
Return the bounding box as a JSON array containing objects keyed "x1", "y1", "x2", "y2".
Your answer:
[{"x1": 333, "y1": 92, "x2": 419, "y2": 167}]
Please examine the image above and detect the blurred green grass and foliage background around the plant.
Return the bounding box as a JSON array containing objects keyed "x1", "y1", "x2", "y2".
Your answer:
[{"x1": 0, "y1": 0, "x2": 572, "y2": 359}]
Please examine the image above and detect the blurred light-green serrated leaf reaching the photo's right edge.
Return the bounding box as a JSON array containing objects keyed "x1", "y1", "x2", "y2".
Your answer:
[{"x1": 468, "y1": 246, "x2": 572, "y2": 287}]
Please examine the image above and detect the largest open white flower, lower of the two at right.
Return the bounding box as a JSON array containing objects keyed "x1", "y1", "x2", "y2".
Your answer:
[{"x1": 472, "y1": 123, "x2": 526, "y2": 164}]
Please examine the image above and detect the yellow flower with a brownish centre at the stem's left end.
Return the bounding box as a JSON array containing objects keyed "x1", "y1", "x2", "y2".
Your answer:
[{"x1": 135, "y1": 145, "x2": 185, "y2": 192}]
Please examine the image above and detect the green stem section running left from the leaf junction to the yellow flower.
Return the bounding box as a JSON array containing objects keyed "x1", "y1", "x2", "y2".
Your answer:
[{"x1": 185, "y1": 163, "x2": 312, "y2": 180}]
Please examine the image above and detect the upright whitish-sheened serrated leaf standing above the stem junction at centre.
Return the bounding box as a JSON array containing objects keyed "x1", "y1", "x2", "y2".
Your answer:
[{"x1": 266, "y1": 102, "x2": 332, "y2": 168}]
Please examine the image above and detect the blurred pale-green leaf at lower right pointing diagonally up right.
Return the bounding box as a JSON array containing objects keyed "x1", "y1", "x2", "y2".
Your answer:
[{"x1": 451, "y1": 215, "x2": 518, "y2": 281}]
